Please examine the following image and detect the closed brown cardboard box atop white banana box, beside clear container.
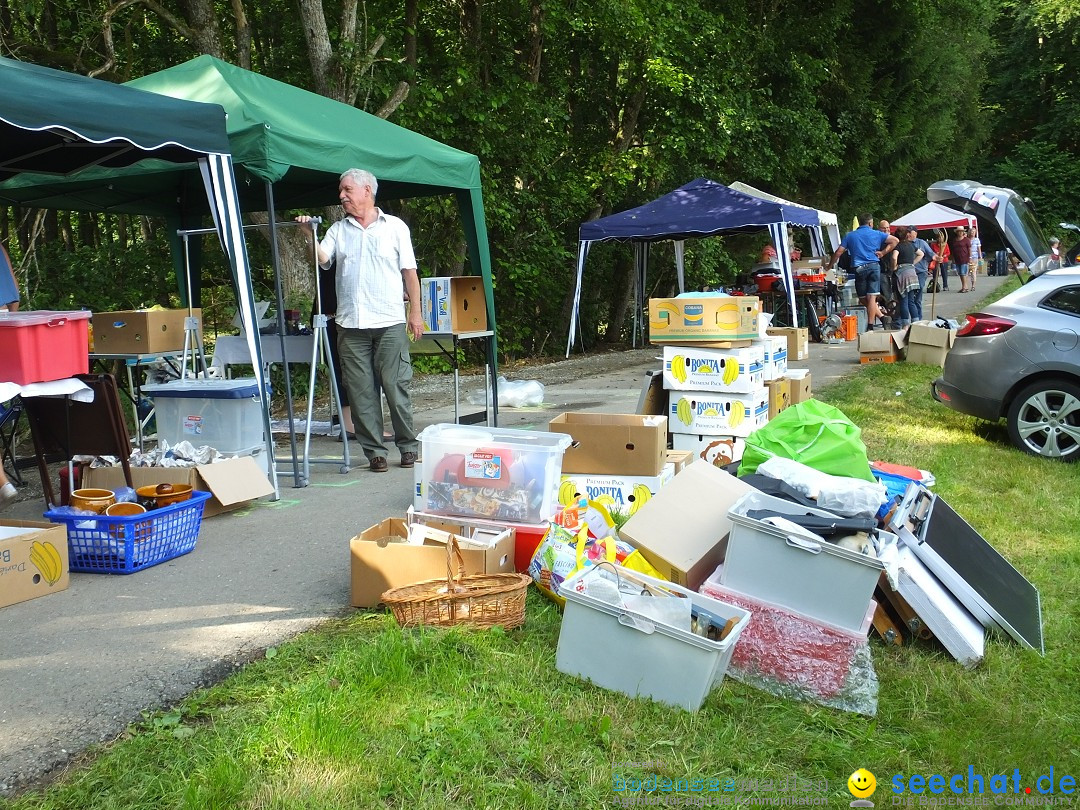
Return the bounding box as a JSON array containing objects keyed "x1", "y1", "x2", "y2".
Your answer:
[{"x1": 548, "y1": 413, "x2": 667, "y2": 475}]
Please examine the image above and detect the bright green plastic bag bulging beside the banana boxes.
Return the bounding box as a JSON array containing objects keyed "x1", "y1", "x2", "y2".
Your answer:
[{"x1": 739, "y1": 400, "x2": 874, "y2": 481}]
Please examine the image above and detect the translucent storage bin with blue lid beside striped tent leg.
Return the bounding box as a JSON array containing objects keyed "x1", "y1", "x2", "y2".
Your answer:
[{"x1": 143, "y1": 378, "x2": 264, "y2": 455}]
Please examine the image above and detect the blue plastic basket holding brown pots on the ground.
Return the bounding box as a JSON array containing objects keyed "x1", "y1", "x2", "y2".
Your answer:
[{"x1": 45, "y1": 491, "x2": 211, "y2": 573}]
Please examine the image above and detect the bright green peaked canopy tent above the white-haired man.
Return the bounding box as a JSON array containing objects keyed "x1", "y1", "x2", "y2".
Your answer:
[{"x1": 3, "y1": 56, "x2": 498, "y2": 488}]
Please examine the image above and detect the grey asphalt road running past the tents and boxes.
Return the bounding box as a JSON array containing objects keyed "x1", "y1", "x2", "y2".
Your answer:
[{"x1": 0, "y1": 278, "x2": 1004, "y2": 795}]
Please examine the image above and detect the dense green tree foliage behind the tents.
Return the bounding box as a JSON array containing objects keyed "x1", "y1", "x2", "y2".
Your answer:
[{"x1": 0, "y1": 0, "x2": 1080, "y2": 356}]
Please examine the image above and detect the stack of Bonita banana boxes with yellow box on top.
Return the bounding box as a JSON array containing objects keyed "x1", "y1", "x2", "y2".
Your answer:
[{"x1": 649, "y1": 294, "x2": 791, "y2": 467}]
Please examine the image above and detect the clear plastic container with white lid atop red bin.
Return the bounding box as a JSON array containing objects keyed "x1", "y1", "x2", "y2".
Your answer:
[{"x1": 414, "y1": 423, "x2": 572, "y2": 523}]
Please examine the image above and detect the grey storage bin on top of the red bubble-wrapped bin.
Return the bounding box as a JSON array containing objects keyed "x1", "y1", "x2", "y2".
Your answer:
[{"x1": 720, "y1": 492, "x2": 885, "y2": 633}]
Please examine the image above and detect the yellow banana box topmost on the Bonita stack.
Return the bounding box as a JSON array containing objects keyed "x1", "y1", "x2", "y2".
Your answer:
[{"x1": 649, "y1": 295, "x2": 761, "y2": 343}]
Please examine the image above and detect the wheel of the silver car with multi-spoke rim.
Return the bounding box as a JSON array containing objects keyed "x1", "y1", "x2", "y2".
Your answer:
[{"x1": 1008, "y1": 379, "x2": 1080, "y2": 461}]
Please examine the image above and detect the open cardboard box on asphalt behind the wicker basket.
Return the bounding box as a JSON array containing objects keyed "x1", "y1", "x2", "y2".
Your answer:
[{"x1": 349, "y1": 517, "x2": 514, "y2": 607}]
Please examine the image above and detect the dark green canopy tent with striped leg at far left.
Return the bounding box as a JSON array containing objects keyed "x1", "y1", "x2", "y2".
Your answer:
[{"x1": 0, "y1": 57, "x2": 278, "y2": 498}]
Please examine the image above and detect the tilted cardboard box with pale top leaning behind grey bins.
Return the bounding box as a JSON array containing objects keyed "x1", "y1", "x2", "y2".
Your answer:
[{"x1": 619, "y1": 464, "x2": 754, "y2": 591}]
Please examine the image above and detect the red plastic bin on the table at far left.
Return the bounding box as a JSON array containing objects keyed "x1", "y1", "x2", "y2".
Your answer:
[{"x1": 0, "y1": 310, "x2": 91, "y2": 386}]
